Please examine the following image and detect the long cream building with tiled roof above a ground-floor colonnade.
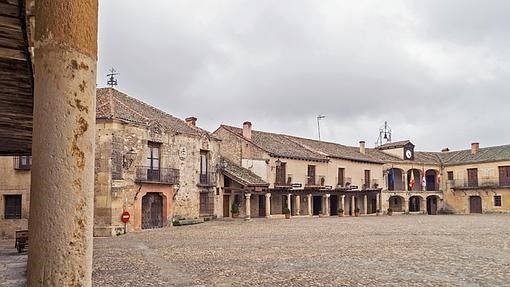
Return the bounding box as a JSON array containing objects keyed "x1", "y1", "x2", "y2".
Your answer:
[{"x1": 213, "y1": 122, "x2": 384, "y2": 217}]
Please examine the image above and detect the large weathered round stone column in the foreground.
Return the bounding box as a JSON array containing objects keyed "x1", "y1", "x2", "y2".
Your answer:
[{"x1": 27, "y1": 0, "x2": 98, "y2": 286}]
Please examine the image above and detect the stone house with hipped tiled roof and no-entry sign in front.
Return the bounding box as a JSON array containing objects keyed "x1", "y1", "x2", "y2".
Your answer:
[{"x1": 94, "y1": 88, "x2": 222, "y2": 236}]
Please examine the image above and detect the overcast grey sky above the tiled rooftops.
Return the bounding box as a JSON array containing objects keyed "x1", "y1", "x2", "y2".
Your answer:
[{"x1": 98, "y1": 0, "x2": 510, "y2": 151}]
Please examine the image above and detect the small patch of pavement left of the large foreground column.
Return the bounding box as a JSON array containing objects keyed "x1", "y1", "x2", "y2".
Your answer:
[{"x1": 0, "y1": 239, "x2": 27, "y2": 287}]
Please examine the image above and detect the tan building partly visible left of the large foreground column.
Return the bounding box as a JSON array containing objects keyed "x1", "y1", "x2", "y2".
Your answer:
[{"x1": 0, "y1": 156, "x2": 32, "y2": 238}]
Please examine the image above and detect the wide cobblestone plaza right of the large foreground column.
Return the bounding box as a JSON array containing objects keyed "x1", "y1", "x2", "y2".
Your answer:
[{"x1": 93, "y1": 215, "x2": 510, "y2": 286}]
